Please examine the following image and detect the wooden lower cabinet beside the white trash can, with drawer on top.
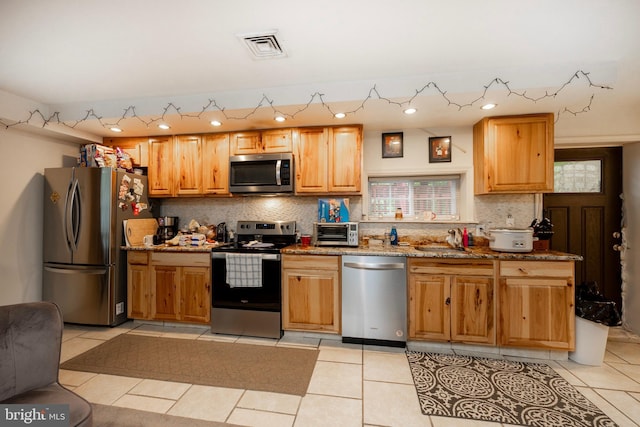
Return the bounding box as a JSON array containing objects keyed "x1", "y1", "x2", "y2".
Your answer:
[{"x1": 499, "y1": 261, "x2": 575, "y2": 351}]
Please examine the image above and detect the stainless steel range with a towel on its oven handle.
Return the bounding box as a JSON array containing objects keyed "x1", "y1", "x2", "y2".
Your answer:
[{"x1": 211, "y1": 221, "x2": 296, "y2": 338}]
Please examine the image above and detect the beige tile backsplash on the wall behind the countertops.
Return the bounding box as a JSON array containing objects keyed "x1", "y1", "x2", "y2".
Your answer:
[{"x1": 154, "y1": 194, "x2": 535, "y2": 238}]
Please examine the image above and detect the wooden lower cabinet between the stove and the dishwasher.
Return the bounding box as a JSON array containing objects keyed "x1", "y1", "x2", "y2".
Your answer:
[{"x1": 282, "y1": 255, "x2": 342, "y2": 334}]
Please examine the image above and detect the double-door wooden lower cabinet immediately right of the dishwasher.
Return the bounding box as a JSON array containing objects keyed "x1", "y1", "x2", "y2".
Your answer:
[{"x1": 407, "y1": 258, "x2": 496, "y2": 345}]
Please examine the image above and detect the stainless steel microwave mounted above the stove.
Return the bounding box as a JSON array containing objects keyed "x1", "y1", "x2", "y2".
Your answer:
[{"x1": 229, "y1": 153, "x2": 294, "y2": 193}]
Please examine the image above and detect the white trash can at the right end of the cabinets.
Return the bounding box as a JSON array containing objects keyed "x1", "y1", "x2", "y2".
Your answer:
[{"x1": 569, "y1": 316, "x2": 609, "y2": 366}]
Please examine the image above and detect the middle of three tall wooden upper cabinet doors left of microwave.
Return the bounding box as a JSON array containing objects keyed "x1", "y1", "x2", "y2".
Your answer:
[{"x1": 175, "y1": 135, "x2": 202, "y2": 196}]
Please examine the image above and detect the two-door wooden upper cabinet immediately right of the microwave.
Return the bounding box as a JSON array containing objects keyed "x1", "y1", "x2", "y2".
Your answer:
[{"x1": 293, "y1": 125, "x2": 362, "y2": 194}]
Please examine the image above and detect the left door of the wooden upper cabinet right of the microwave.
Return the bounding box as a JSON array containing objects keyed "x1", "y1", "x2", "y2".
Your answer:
[{"x1": 294, "y1": 127, "x2": 329, "y2": 193}]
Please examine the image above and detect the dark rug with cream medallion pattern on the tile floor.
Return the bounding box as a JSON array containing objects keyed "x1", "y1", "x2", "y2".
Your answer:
[{"x1": 407, "y1": 351, "x2": 616, "y2": 427}]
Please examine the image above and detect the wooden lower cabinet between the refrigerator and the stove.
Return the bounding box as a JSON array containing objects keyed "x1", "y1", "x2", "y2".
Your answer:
[{"x1": 127, "y1": 251, "x2": 211, "y2": 324}]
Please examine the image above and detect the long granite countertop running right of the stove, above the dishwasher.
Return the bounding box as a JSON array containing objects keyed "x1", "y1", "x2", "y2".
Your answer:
[{"x1": 282, "y1": 245, "x2": 582, "y2": 261}]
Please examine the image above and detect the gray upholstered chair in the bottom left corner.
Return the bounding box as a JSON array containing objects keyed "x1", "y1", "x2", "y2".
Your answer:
[{"x1": 0, "y1": 302, "x2": 92, "y2": 427}]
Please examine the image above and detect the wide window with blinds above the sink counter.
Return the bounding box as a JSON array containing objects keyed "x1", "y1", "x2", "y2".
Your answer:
[{"x1": 369, "y1": 175, "x2": 460, "y2": 220}]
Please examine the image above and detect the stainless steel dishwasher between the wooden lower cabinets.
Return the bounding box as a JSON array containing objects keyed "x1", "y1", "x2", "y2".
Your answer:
[{"x1": 342, "y1": 255, "x2": 407, "y2": 347}]
